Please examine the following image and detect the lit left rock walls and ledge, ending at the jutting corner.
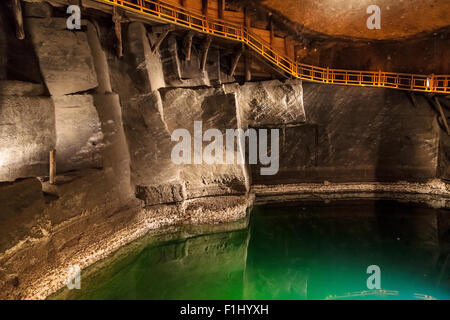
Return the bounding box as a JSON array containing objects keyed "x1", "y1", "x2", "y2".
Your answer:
[{"x1": 0, "y1": 3, "x2": 256, "y2": 298}]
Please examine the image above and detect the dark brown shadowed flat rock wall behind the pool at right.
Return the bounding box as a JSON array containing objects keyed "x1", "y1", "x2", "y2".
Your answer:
[{"x1": 252, "y1": 83, "x2": 440, "y2": 184}]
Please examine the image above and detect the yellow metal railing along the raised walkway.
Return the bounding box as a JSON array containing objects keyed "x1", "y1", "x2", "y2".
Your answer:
[{"x1": 96, "y1": 0, "x2": 450, "y2": 93}]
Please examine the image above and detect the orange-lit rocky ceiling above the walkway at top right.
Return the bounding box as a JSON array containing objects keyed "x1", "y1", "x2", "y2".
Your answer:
[{"x1": 261, "y1": 0, "x2": 450, "y2": 40}]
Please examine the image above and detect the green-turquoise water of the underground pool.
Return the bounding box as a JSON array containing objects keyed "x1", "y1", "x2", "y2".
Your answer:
[{"x1": 51, "y1": 201, "x2": 450, "y2": 299}]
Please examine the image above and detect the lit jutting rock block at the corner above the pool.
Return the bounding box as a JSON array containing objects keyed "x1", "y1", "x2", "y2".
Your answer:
[{"x1": 127, "y1": 88, "x2": 248, "y2": 205}]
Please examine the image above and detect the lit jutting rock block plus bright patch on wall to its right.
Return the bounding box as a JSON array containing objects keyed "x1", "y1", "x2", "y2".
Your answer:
[{"x1": 126, "y1": 80, "x2": 305, "y2": 205}]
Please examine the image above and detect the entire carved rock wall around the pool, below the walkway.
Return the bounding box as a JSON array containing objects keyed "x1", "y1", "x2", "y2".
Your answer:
[{"x1": 0, "y1": 0, "x2": 448, "y2": 298}]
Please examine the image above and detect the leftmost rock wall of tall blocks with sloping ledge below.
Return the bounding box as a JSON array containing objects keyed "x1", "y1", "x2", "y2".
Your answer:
[{"x1": 0, "y1": 3, "x2": 137, "y2": 298}]
